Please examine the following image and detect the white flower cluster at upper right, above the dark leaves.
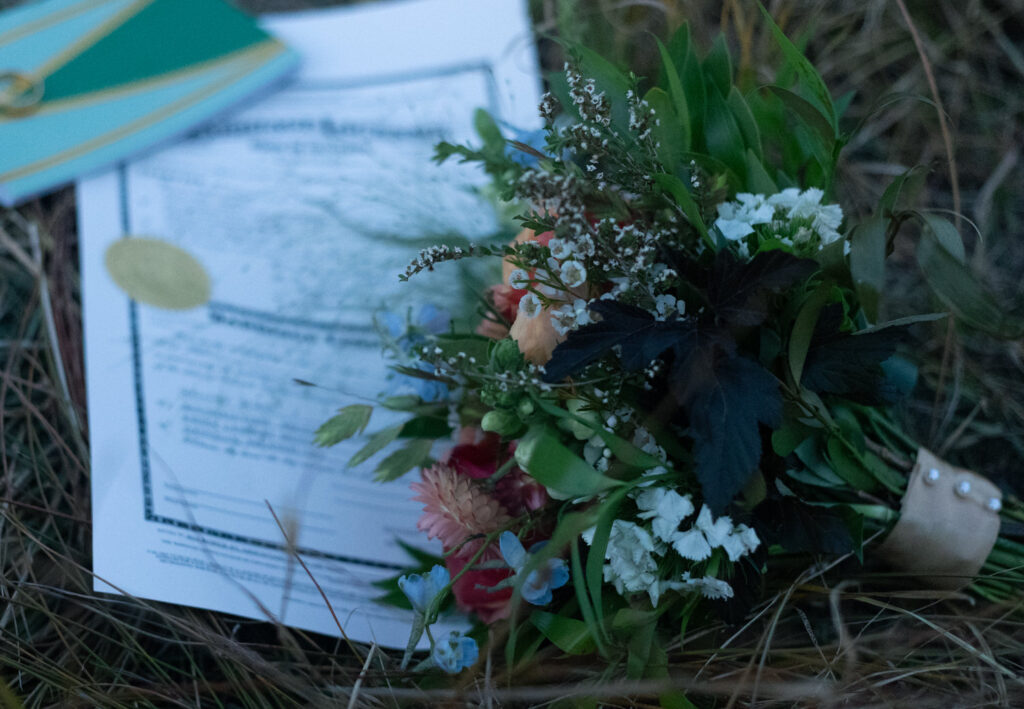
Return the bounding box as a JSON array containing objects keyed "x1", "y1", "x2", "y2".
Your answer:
[{"x1": 715, "y1": 187, "x2": 843, "y2": 252}]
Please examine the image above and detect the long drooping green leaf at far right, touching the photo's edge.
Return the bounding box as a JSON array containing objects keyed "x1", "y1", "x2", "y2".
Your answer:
[{"x1": 918, "y1": 232, "x2": 1024, "y2": 339}]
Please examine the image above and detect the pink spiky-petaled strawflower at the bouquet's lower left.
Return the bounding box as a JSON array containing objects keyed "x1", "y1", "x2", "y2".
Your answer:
[{"x1": 411, "y1": 463, "x2": 511, "y2": 549}]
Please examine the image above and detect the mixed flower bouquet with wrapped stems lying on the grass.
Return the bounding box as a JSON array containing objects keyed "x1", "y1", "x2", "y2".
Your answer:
[{"x1": 321, "y1": 12, "x2": 1024, "y2": 676}]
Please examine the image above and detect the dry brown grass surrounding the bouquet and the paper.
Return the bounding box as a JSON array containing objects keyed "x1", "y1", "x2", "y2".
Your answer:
[{"x1": 0, "y1": 0, "x2": 1024, "y2": 707}]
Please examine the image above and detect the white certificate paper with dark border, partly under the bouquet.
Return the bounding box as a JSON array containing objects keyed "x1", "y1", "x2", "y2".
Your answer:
[{"x1": 78, "y1": 0, "x2": 539, "y2": 647}]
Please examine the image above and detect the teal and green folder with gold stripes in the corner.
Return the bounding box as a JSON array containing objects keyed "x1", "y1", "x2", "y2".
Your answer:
[{"x1": 0, "y1": 0, "x2": 298, "y2": 206}]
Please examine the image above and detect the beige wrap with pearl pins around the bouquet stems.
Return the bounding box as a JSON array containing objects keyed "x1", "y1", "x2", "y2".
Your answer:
[{"x1": 879, "y1": 448, "x2": 1002, "y2": 590}]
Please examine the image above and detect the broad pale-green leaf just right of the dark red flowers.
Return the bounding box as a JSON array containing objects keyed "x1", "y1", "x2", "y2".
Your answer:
[{"x1": 515, "y1": 425, "x2": 622, "y2": 497}]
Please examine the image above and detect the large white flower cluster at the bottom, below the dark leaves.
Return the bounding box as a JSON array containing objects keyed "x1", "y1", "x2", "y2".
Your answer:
[{"x1": 584, "y1": 488, "x2": 761, "y2": 606}]
